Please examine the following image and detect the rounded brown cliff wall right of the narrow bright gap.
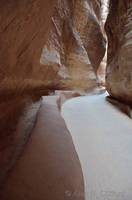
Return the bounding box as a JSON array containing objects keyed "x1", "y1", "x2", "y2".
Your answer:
[{"x1": 106, "y1": 0, "x2": 132, "y2": 104}]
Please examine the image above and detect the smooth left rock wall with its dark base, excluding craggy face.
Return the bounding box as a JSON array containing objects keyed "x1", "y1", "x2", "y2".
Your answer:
[{"x1": 0, "y1": 0, "x2": 55, "y2": 184}]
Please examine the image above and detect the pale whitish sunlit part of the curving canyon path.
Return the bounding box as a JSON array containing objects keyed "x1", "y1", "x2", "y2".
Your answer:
[{"x1": 62, "y1": 93, "x2": 132, "y2": 200}]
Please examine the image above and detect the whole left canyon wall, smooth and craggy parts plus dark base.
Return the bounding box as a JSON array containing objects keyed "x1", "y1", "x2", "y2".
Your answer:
[{"x1": 0, "y1": 0, "x2": 105, "y2": 182}]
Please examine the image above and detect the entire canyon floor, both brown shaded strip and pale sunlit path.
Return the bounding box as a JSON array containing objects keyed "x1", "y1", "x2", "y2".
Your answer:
[{"x1": 0, "y1": 93, "x2": 132, "y2": 200}]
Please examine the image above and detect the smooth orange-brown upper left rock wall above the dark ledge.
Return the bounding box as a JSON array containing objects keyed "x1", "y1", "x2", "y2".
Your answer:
[{"x1": 0, "y1": 0, "x2": 57, "y2": 93}]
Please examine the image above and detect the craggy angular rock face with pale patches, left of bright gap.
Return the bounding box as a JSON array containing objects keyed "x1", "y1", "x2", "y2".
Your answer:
[{"x1": 40, "y1": 0, "x2": 105, "y2": 88}]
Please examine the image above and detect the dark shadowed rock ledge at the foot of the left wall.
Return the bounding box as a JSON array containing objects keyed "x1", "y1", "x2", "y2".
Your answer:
[{"x1": 0, "y1": 97, "x2": 41, "y2": 185}]
